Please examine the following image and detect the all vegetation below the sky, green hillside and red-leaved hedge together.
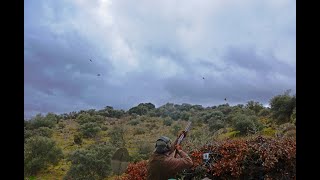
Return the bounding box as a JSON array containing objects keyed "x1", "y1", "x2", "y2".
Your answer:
[{"x1": 24, "y1": 91, "x2": 296, "y2": 179}]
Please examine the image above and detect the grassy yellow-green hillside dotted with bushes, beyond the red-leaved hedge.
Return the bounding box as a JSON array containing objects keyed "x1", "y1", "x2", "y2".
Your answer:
[{"x1": 24, "y1": 93, "x2": 296, "y2": 180}]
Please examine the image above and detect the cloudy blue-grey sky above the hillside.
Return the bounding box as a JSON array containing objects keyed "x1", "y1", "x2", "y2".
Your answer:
[{"x1": 24, "y1": 0, "x2": 296, "y2": 118}]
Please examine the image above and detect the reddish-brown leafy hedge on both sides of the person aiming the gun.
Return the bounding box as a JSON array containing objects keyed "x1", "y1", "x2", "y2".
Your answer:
[{"x1": 121, "y1": 136, "x2": 296, "y2": 180}]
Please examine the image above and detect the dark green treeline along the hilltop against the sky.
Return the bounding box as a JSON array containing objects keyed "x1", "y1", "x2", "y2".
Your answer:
[{"x1": 26, "y1": 91, "x2": 296, "y2": 126}]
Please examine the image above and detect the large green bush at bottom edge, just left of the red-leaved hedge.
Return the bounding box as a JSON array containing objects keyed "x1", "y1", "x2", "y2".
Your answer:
[{"x1": 64, "y1": 144, "x2": 115, "y2": 180}]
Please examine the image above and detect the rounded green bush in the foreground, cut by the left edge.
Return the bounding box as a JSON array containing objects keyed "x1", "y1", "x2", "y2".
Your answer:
[{"x1": 24, "y1": 136, "x2": 63, "y2": 176}]
